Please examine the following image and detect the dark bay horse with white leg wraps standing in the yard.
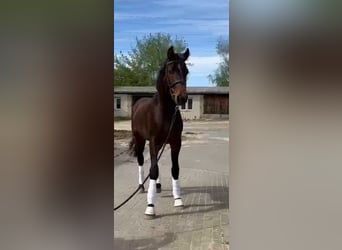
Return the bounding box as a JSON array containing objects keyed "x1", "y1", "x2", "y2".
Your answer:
[{"x1": 130, "y1": 46, "x2": 190, "y2": 216}]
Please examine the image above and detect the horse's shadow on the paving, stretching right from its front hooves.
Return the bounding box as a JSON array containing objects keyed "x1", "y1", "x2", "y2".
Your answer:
[{"x1": 158, "y1": 186, "x2": 229, "y2": 217}]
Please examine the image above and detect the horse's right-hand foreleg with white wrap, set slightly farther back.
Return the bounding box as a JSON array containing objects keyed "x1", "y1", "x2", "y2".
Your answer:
[{"x1": 171, "y1": 142, "x2": 184, "y2": 207}]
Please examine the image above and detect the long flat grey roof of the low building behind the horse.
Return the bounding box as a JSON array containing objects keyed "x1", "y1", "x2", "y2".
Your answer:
[{"x1": 114, "y1": 86, "x2": 229, "y2": 95}]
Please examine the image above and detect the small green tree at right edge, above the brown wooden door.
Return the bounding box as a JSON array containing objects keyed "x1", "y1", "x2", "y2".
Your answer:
[{"x1": 208, "y1": 39, "x2": 229, "y2": 86}]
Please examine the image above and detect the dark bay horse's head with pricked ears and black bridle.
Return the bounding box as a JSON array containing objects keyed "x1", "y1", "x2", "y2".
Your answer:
[{"x1": 165, "y1": 46, "x2": 190, "y2": 105}]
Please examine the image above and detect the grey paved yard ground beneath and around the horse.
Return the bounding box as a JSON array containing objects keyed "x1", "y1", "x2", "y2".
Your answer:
[{"x1": 114, "y1": 121, "x2": 229, "y2": 250}]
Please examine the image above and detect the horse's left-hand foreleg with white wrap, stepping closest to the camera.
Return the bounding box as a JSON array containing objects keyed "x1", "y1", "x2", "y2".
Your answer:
[{"x1": 145, "y1": 140, "x2": 159, "y2": 216}]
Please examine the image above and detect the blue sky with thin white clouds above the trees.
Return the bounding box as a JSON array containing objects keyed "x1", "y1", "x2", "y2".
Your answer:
[{"x1": 114, "y1": 0, "x2": 229, "y2": 86}]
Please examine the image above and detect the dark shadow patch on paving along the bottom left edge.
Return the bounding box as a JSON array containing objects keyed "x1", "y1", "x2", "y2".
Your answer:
[{"x1": 114, "y1": 233, "x2": 174, "y2": 250}]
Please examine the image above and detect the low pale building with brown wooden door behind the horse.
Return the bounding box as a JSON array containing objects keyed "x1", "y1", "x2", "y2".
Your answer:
[{"x1": 114, "y1": 87, "x2": 229, "y2": 120}]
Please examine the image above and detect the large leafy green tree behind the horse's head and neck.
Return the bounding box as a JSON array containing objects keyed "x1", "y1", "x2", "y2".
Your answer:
[{"x1": 114, "y1": 33, "x2": 187, "y2": 86}]
